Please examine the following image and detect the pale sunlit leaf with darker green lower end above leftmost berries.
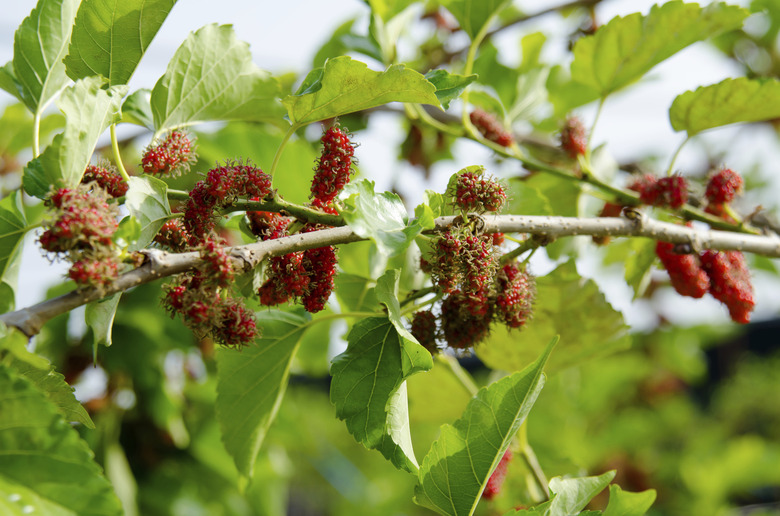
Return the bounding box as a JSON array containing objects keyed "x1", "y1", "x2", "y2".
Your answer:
[{"x1": 24, "y1": 77, "x2": 127, "y2": 198}]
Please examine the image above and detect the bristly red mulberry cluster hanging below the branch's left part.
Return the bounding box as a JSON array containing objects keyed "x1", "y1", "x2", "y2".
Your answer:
[{"x1": 163, "y1": 239, "x2": 258, "y2": 347}]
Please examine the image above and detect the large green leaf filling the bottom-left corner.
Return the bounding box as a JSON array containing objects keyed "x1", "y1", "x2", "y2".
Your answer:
[{"x1": 0, "y1": 364, "x2": 122, "y2": 516}]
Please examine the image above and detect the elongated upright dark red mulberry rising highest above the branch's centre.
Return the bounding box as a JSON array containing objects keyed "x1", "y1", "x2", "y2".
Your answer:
[{"x1": 311, "y1": 125, "x2": 355, "y2": 205}]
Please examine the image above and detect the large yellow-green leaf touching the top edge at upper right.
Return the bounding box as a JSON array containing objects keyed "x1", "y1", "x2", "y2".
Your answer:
[{"x1": 571, "y1": 1, "x2": 748, "y2": 97}]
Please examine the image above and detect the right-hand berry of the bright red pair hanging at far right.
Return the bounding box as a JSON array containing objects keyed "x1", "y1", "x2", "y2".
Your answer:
[{"x1": 701, "y1": 250, "x2": 756, "y2": 324}]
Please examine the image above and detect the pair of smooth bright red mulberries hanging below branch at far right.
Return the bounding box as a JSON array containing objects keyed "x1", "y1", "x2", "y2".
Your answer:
[{"x1": 656, "y1": 237, "x2": 755, "y2": 324}]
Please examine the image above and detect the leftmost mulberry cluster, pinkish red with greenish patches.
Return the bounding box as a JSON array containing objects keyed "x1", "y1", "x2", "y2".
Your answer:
[{"x1": 39, "y1": 181, "x2": 119, "y2": 289}]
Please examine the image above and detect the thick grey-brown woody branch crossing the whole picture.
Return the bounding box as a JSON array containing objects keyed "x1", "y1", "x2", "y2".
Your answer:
[{"x1": 0, "y1": 215, "x2": 780, "y2": 336}]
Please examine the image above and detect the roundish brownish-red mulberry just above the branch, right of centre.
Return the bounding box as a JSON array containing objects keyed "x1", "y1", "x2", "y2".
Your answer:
[{"x1": 449, "y1": 167, "x2": 507, "y2": 213}]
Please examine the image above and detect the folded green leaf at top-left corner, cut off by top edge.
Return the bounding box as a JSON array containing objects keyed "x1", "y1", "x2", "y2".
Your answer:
[{"x1": 13, "y1": 0, "x2": 79, "y2": 113}]
